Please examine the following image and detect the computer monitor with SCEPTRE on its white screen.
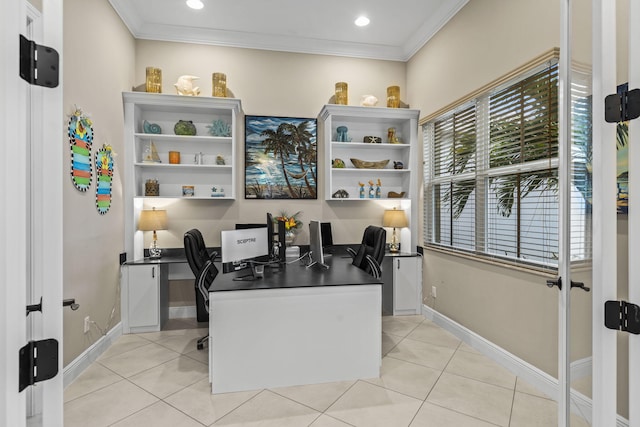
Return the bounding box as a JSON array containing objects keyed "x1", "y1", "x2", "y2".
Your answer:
[{"x1": 220, "y1": 225, "x2": 269, "y2": 275}]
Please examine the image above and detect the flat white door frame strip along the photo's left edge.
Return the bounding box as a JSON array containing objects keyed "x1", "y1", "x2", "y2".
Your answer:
[{"x1": 0, "y1": 0, "x2": 27, "y2": 426}]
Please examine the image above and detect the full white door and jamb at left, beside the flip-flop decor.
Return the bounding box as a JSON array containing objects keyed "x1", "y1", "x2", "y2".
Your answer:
[{"x1": 0, "y1": 0, "x2": 64, "y2": 427}]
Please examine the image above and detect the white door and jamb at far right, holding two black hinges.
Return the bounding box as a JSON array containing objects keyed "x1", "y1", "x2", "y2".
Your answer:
[{"x1": 592, "y1": 0, "x2": 640, "y2": 427}]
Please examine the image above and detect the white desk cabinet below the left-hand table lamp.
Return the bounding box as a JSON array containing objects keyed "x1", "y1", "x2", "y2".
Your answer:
[{"x1": 120, "y1": 264, "x2": 169, "y2": 334}]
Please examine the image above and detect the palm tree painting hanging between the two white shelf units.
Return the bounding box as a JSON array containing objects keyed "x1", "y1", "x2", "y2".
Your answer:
[{"x1": 244, "y1": 116, "x2": 318, "y2": 199}]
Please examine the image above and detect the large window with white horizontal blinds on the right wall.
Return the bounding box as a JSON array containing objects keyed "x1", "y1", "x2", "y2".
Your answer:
[{"x1": 423, "y1": 61, "x2": 590, "y2": 268}]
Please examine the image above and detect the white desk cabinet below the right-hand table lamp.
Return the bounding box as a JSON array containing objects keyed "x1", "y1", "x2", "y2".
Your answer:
[{"x1": 382, "y1": 253, "x2": 422, "y2": 316}]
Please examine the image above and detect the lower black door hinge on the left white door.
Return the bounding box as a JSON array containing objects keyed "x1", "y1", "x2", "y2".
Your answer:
[{"x1": 18, "y1": 338, "x2": 58, "y2": 391}]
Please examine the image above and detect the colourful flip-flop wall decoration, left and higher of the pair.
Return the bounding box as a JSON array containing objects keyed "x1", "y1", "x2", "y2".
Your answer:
[{"x1": 67, "y1": 107, "x2": 93, "y2": 191}]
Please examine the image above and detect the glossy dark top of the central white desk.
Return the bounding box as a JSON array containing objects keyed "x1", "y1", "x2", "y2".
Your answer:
[{"x1": 209, "y1": 255, "x2": 382, "y2": 292}]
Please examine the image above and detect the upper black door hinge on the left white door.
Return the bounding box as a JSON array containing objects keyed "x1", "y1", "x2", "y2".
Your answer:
[{"x1": 20, "y1": 34, "x2": 60, "y2": 88}]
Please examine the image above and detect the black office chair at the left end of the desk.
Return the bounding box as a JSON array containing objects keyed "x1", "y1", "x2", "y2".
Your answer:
[{"x1": 184, "y1": 228, "x2": 218, "y2": 350}]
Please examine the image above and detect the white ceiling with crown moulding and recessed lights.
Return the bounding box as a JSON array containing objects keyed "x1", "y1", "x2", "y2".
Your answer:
[{"x1": 109, "y1": 0, "x2": 469, "y2": 61}]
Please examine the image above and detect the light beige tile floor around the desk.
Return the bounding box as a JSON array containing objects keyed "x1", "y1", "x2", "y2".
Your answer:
[{"x1": 64, "y1": 316, "x2": 588, "y2": 427}]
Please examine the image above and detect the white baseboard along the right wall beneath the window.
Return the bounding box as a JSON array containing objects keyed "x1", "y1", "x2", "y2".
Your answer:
[{"x1": 422, "y1": 304, "x2": 629, "y2": 427}]
